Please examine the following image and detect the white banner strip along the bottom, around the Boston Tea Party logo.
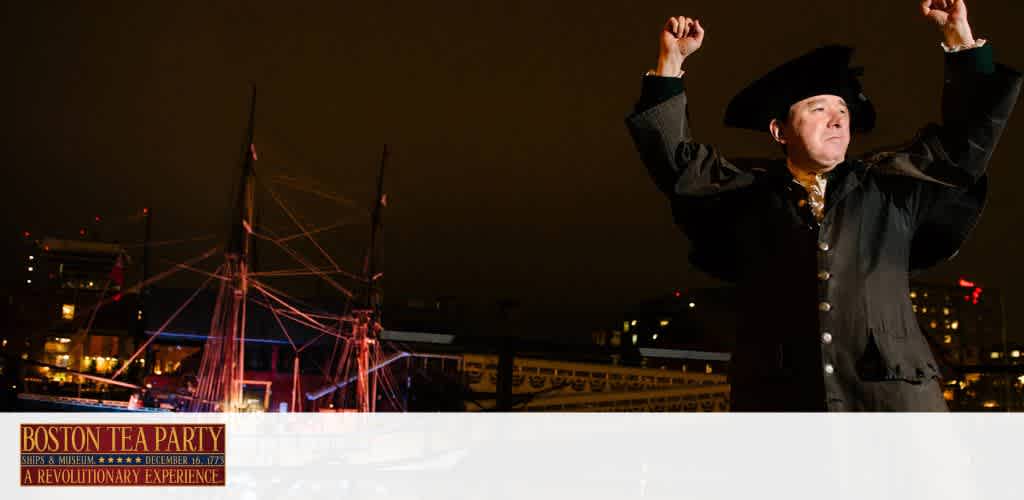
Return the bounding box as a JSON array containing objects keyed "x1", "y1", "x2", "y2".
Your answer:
[{"x1": 0, "y1": 413, "x2": 1024, "y2": 500}]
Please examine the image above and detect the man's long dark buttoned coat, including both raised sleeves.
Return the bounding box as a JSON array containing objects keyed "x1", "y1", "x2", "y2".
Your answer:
[{"x1": 627, "y1": 47, "x2": 1021, "y2": 411}]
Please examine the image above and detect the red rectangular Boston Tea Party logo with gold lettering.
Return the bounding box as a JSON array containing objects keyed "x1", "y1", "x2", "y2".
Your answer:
[{"x1": 19, "y1": 424, "x2": 225, "y2": 486}]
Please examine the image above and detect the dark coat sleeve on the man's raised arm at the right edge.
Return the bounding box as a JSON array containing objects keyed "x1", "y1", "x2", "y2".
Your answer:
[{"x1": 869, "y1": 45, "x2": 1021, "y2": 270}]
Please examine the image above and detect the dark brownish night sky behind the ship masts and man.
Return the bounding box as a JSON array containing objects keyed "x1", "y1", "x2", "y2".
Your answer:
[{"x1": 0, "y1": 0, "x2": 1024, "y2": 336}]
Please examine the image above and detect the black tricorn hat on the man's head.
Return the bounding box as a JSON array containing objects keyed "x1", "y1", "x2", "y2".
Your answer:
[{"x1": 725, "y1": 45, "x2": 874, "y2": 132}]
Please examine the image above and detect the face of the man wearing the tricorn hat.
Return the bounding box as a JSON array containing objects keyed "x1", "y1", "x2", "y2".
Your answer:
[{"x1": 782, "y1": 95, "x2": 850, "y2": 171}]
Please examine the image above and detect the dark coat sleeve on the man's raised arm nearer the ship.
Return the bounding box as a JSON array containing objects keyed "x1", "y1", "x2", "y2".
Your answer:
[{"x1": 626, "y1": 77, "x2": 755, "y2": 282}]
